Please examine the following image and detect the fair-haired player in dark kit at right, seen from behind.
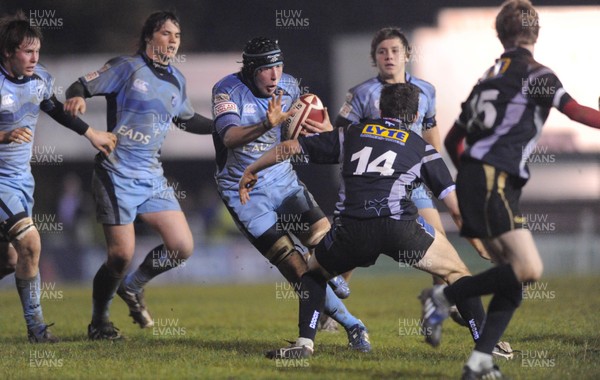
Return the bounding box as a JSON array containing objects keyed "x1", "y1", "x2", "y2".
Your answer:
[{"x1": 425, "y1": 0, "x2": 600, "y2": 379}]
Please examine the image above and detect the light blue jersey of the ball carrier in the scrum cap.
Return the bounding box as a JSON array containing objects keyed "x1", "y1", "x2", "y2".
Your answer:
[{"x1": 212, "y1": 73, "x2": 300, "y2": 189}]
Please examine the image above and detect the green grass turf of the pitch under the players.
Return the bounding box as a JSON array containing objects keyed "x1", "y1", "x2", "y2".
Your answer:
[{"x1": 0, "y1": 270, "x2": 600, "y2": 380}]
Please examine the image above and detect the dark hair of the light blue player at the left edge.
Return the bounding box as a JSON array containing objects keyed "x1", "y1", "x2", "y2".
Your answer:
[{"x1": 0, "y1": 11, "x2": 43, "y2": 60}]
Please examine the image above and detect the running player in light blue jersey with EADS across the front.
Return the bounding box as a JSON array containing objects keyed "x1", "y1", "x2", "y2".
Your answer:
[{"x1": 65, "y1": 11, "x2": 212, "y2": 339}]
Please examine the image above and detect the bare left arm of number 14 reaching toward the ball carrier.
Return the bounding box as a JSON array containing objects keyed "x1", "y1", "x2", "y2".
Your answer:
[{"x1": 238, "y1": 140, "x2": 302, "y2": 204}]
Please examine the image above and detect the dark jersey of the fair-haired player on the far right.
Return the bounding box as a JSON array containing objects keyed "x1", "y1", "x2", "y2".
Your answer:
[{"x1": 456, "y1": 48, "x2": 571, "y2": 179}]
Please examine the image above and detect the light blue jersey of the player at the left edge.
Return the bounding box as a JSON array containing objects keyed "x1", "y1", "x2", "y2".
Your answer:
[{"x1": 0, "y1": 64, "x2": 55, "y2": 178}]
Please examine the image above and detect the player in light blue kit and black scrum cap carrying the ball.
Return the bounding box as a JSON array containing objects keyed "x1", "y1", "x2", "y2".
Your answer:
[{"x1": 212, "y1": 37, "x2": 371, "y2": 351}]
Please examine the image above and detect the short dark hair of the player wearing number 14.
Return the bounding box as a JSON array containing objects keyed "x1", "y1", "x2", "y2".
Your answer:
[{"x1": 379, "y1": 83, "x2": 420, "y2": 125}]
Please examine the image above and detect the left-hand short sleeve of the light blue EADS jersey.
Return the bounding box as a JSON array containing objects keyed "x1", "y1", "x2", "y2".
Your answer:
[{"x1": 79, "y1": 57, "x2": 132, "y2": 96}]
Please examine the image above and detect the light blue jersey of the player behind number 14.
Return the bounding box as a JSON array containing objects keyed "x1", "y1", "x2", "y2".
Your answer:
[{"x1": 339, "y1": 73, "x2": 436, "y2": 136}]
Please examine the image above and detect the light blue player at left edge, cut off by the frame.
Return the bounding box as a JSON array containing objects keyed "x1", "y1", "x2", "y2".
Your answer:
[{"x1": 0, "y1": 13, "x2": 116, "y2": 343}]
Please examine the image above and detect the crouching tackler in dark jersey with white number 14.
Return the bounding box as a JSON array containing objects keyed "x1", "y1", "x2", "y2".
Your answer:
[{"x1": 239, "y1": 83, "x2": 482, "y2": 359}]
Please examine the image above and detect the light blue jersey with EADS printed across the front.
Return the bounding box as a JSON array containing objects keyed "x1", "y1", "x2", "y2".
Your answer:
[{"x1": 79, "y1": 54, "x2": 194, "y2": 179}]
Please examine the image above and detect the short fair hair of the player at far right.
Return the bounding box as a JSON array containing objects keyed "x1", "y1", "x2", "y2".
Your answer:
[{"x1": 496, "y1": 0, "x2": 540, "y2": 49}]
